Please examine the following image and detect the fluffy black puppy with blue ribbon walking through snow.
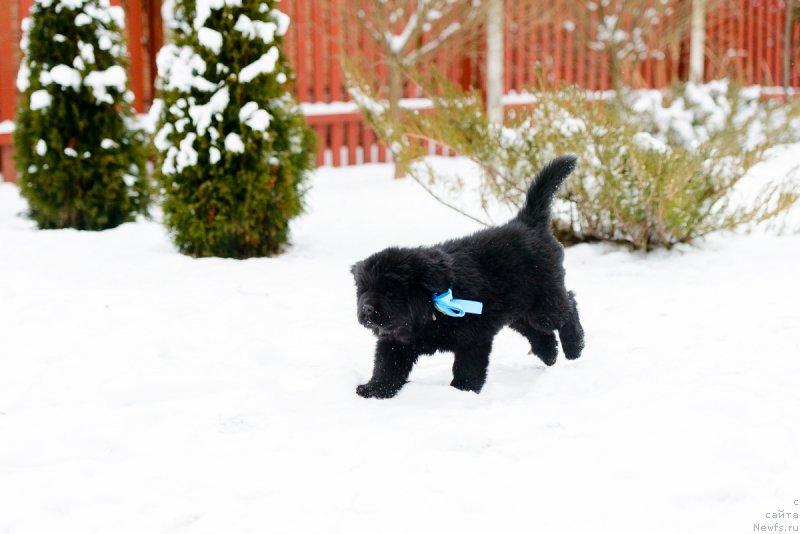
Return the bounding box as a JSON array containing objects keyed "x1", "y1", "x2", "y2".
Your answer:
[{"x1": 352, "y1": 156, "x2": 583, "y2": 398}]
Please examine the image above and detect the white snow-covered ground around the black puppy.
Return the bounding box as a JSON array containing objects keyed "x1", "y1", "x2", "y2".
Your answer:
[{"x1": 0, "y1": 151, "x2": 800, "y2": 534}]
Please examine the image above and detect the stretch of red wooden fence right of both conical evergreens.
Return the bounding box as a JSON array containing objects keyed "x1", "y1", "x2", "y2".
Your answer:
[{"x1": 281, "y1": 0, "x2": 800, "y2": 166}]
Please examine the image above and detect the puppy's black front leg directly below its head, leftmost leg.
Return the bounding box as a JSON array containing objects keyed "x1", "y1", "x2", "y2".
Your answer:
[{"x1": 356, "y1": 340, "x2": 417, "y2": 399}]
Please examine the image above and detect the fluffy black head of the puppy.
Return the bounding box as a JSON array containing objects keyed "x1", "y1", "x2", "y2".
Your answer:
[{"x1": 350, "y1": 248, "x2": 453, "y2": 342}]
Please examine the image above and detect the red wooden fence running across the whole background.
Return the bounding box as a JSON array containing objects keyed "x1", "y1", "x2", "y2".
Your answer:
[{"x1": 0, "y1": 0, "x2": 800, "y2": 179}]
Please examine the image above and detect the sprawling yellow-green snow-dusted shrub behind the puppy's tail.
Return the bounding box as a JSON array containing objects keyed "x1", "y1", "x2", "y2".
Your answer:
[{"x1": 354, "y1": 76, "x2": 800, "y2": 250}]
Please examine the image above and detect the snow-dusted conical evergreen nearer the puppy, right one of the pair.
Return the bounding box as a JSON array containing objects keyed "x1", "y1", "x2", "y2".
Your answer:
[{"x1": 154, "y1": 0, "x2": 314, "y2": 258}]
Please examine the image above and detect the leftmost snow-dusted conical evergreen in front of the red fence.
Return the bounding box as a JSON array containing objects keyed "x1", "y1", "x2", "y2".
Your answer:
[{"x1": 14, "y1": 0, "x2": 148, "y2": 230}]
